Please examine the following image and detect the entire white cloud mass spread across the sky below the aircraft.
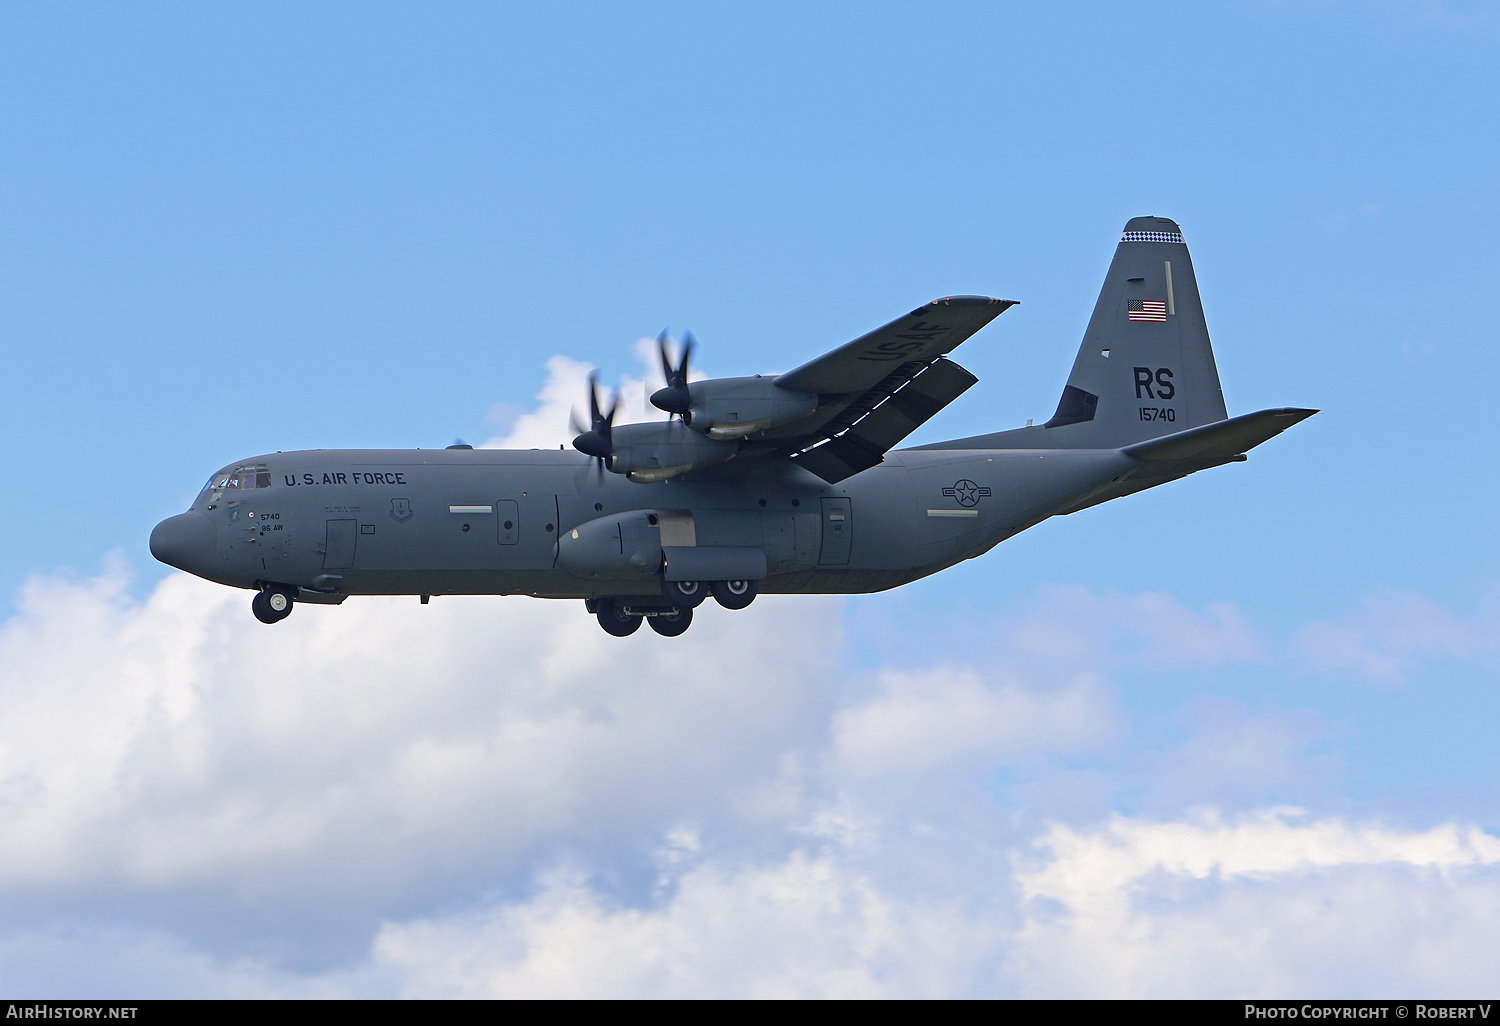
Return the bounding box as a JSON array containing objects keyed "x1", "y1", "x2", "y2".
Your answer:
[{"x1": 0, "y1": 528, "x2": 1500, "y2": 996}]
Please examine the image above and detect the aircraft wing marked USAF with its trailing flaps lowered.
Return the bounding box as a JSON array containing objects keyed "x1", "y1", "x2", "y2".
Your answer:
[{"x1": 752, "y1": 296, "x2": 1016, "y2": 483}]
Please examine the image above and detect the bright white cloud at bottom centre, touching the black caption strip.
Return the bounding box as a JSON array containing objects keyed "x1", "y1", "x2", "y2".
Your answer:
[{"x1": 375, "y1": 852, "x2": 986, "y2": 998}]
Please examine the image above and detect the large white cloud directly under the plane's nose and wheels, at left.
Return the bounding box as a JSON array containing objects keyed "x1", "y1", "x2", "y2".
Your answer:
[{"x1": 0, "y1": 564, "x2": 840, "y2": 909}]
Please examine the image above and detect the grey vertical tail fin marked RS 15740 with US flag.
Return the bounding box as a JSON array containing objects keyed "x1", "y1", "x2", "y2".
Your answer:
[{"x1": 1043, "y1": 218, "x2": 1226, "y2": 449}]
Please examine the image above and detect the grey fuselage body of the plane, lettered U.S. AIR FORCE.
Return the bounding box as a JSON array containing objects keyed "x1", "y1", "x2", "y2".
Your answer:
[{"x1": 152, "y1": 449, "x2": 1136, "y2": 602}]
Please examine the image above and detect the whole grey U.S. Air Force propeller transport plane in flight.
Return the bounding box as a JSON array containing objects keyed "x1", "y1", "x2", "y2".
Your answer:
[{"x1": 152, "y1": 218, "x2": 1317, "y2": 638}]
